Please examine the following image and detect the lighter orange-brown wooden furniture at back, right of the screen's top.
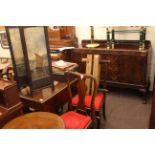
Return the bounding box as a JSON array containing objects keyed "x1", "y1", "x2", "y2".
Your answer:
[{"x1": 48, "y1": 26, "x2": 77, "y2": 48}]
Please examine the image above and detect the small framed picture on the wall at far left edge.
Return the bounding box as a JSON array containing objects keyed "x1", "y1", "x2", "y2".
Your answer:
[{"x1": 0, "y1": 31, "x2": 9, "y2": 49}]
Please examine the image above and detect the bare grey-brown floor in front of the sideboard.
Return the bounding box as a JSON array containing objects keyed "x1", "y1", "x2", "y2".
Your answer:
[{"x1": 101, "y1": 89, "x2": 151, "y2": 129}]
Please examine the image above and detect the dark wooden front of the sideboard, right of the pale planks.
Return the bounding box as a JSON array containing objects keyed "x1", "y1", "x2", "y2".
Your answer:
[{"x1": 101, "y1": 54, "x2": 147, "y2": 85}]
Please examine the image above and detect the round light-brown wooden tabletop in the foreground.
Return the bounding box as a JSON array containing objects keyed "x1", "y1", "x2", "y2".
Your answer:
[{"x1": 3, "y1": 112, "x2": 65, "y2": 129}]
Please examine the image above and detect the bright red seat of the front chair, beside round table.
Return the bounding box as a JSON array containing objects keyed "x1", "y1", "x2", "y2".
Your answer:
[{"x1": 61, "y1": 111, "x2": 91, "y2": 129}]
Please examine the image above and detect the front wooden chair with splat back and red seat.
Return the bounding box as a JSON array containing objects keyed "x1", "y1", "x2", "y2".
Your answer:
[{"x1": 61, "y1": 72, "x2": 96, "y2": 129}]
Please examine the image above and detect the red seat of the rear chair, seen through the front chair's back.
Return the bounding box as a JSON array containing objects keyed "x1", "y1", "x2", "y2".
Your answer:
[{"x1": 72, "y1": 93, "x2": 104, "y2": 110}]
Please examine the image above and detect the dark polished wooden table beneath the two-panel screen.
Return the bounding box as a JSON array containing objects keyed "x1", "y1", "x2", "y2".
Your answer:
[{"x1": 20, "y1": 79, "x2": 76, "y2": 113}]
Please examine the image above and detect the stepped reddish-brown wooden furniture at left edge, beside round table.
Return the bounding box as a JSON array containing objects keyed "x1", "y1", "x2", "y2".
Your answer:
[{"x1": 0, "y1": 79, "x2": 23, "y2": 128}]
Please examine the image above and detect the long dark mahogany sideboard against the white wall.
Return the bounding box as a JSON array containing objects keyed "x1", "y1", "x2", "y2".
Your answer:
[{"x1": 66, "y1": 40, "x2": 151, "y2": 93}]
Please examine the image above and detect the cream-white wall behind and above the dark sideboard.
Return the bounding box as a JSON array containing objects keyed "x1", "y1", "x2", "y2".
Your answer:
[{"x1": 76, "y1": 26, "x2": 155, "y2": 90}]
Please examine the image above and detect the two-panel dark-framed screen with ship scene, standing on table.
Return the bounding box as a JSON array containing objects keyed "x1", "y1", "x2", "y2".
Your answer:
[{"x1": 6, "y1": 26, "x2": 54, "y2": 94}]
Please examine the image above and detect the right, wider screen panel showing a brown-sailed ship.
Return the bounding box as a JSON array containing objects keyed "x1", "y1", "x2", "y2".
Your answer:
[{"x1": 20, "y1": 26, "x2": 54, "y2": 91}]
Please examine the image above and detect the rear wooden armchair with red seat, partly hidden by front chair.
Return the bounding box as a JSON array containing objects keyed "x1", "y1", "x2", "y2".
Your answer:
[{"x1": 65, "y1": 71, "x2": 107, "y2": 128}]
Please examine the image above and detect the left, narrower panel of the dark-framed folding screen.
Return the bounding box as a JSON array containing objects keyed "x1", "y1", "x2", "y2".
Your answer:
[{"x1": 5, "y1": 26, "x2": 30, "y2": 90}]
